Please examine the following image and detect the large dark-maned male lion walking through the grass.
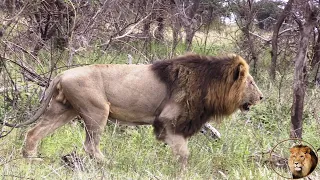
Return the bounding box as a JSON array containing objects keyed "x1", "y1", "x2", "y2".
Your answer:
[{"x1": 5, "y1": 54, "x2": 263, "y2": 166}]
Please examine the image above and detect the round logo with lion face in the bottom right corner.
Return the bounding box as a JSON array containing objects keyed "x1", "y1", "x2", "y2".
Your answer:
[{"x1": 269, "y1": 138, "x2": 318, "y2": 179}]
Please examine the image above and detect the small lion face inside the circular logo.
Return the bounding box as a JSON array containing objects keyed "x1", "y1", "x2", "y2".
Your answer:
[{"x1": 288, "y1": 145, "x2": 318, "y2": 179}]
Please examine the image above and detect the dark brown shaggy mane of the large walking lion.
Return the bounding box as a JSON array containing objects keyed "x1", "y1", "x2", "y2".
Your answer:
[{"x1": 152, "y1": 55, "x2": 249, "y2": 137}]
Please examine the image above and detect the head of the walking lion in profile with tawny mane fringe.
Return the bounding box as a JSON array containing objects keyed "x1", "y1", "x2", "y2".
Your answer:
[{"x1": 207, "y1": 55, "x2": 263, "y2": 115}]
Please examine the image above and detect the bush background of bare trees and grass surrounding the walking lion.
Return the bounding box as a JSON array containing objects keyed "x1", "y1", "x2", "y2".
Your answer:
[{"x1": 0, "y1": 0, "x2": 320, "y2": 179}]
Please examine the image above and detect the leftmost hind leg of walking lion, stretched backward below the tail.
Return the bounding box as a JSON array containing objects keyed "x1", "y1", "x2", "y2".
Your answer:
[{"x1": 22, "y1": 98, "x2": 77, "y2": 157}]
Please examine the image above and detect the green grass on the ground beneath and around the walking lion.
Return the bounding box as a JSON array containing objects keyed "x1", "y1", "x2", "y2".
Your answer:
[{"x1": 0, "y1": 80, "x2": 320, "y2": 180}]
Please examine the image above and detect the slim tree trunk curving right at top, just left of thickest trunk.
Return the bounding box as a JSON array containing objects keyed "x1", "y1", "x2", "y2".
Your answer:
[{"x1": 270, "y1": 0, "x2": 294, "y2": 80}]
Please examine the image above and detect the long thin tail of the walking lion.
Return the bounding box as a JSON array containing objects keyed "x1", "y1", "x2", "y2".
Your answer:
[{"x1": 4, "y1": 75, "x2": 60, "y2": 128}]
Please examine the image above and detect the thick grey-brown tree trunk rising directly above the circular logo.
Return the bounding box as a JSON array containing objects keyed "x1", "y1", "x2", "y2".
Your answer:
[{"x1": 290, "y1": 2, "x2": 317, "y2": 138}]
